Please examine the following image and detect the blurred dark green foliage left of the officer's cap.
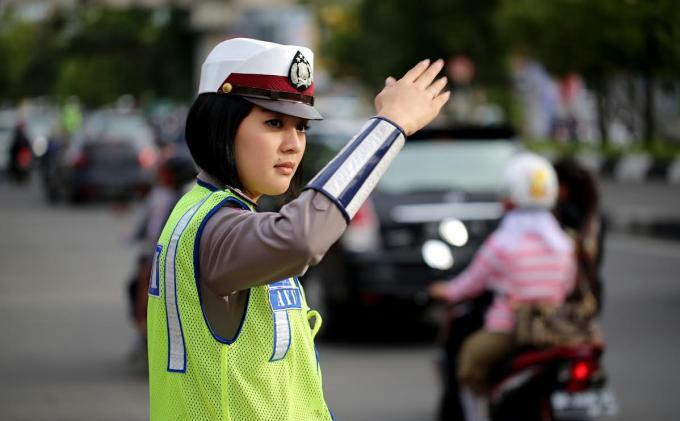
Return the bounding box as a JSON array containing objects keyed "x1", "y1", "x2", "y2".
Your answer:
[{"x1": 0, "y1": 5, "x2": 194, "y2": 106}]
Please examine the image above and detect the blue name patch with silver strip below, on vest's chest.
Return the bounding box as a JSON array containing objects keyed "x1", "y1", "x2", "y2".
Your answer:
[{"x1": 267, "y1": 278, "x2": 302, "y2": 362}]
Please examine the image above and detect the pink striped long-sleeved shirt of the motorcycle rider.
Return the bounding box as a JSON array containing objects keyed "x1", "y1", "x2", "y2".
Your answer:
[{"x1": 447, "y1": 231, "x2": 576, "y2": 332}]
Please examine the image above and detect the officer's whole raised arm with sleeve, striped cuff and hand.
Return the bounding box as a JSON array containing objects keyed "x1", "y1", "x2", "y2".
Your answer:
[{"x1": 198, "y1": 60, "x2": 449, "y2": 295}]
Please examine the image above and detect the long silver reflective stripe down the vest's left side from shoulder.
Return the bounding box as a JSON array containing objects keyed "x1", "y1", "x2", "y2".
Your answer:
[{"x1": 165, "y1": 196, "x2": 209, "y2": 372}]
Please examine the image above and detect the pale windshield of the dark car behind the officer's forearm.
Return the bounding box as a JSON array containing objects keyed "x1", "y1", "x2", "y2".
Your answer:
[{"x1": 378, "y1": 140, "x2": 518, "y2": 193}]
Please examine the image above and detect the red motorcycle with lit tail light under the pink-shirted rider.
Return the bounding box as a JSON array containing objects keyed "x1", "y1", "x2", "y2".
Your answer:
[{"x1": 439, "y1": 294, "x2": 618, "y2": 421}]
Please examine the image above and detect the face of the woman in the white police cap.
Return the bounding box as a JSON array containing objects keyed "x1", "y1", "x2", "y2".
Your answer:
[{"x1": 234, "y1": 106, "x2": 307, "y2": 201}]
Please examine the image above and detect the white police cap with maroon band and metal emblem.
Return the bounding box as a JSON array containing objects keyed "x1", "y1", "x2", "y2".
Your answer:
[{"x1": 198, "y1": 38, "x2": 323, "y2": 120}]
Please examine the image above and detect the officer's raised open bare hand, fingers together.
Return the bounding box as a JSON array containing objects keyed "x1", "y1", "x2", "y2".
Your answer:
[{"x1": 375, "y1": 59, "x2": 451, "y2": 136}]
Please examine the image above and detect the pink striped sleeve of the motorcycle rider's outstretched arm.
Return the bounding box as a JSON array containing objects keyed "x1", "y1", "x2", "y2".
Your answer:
[{"x1": 446, "y1": 238, "x2": 499, "y2": 301}]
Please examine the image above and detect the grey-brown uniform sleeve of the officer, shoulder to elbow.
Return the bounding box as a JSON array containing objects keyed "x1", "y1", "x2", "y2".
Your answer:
[{"x1": 197, "y1": 190, "x2": 347, "y2": 296}]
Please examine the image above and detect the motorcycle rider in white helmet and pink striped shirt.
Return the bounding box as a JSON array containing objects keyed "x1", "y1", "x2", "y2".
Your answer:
[{"x1": 429, "y1": 153, "x2": 576, "y2": 419}]
